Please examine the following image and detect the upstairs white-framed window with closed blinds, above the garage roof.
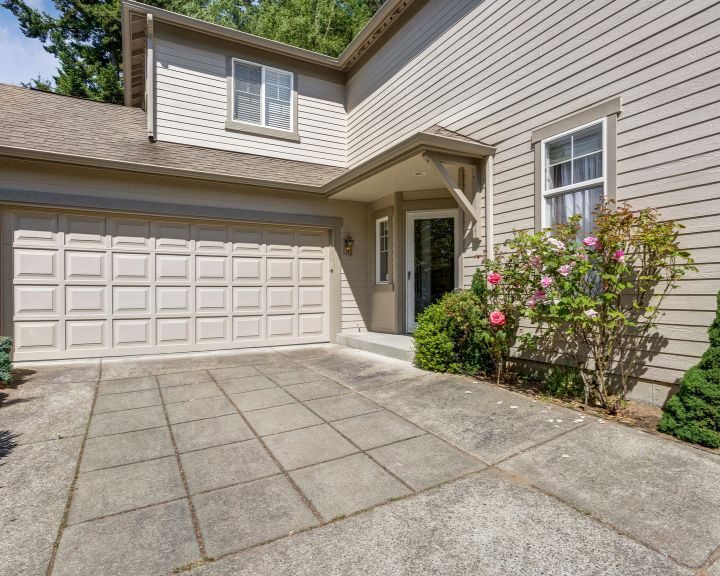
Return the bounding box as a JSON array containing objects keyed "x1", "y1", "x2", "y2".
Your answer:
[{"x1": 232, "y1": 58, "x2": 294, "y2": 132}]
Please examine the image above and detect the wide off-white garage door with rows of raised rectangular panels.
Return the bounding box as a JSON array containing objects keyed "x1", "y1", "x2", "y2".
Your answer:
[{"x1": 4, "y1": 209, "x2": 329, "y2": 360}]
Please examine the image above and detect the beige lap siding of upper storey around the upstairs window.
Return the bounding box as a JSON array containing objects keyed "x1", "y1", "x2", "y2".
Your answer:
[{"x1": 155, "y1": 35, "x2": 346, "y2": 166}]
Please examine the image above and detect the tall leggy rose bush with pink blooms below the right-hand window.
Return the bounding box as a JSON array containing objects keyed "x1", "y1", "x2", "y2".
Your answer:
[{"x1": 507, "y1": 202, "x2": 694, "y2": 411}]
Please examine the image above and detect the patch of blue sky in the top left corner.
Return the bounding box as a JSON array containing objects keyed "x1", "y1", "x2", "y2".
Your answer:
[{"x1": 0, "y1": 0, "x2": 57, "y2": 84}]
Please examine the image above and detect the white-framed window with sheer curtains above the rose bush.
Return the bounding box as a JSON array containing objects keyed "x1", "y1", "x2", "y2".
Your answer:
[{"x1": 541, "y1": 119, "x2": 607, "y2": 233}]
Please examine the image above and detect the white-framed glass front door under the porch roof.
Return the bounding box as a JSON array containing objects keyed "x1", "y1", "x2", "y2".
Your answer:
[{"x1": 406, "y1": 210, "x2": 459, "y2": 332}]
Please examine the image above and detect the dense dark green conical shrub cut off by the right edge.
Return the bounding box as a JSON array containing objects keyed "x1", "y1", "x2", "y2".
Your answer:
[{"x1": 658, "y1": 293, "x2": 720, "y2": 448}]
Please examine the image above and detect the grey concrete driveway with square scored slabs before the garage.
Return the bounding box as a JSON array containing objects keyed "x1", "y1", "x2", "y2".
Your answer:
[{"x1": 0, "y1": 345, "x2": 720, "y2": 576}]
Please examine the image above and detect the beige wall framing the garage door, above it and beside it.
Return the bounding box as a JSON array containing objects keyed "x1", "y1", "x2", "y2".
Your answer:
[{"x1": 0, "y1": 161, "x2": 368, "y2": 340}]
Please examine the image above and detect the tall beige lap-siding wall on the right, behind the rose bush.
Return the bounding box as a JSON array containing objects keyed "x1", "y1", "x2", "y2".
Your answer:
[{"x1": 347, "y1": 0, "x2": 720, "y2": 390}]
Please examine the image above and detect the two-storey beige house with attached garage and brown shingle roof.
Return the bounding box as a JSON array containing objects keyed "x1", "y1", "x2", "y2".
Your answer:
[{"x1": 0, "y1": 0, "x2": 720, "y2": 403}]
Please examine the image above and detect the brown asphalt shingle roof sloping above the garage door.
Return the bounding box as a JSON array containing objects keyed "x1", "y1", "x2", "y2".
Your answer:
[{"x1": 0, "y1": 84, "x2": 346, "y2": 192}]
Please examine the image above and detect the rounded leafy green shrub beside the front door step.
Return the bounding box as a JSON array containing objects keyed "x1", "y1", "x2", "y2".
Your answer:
[{"x1": 413, "y1": 291, "x2": 491, "y2": 373}]
